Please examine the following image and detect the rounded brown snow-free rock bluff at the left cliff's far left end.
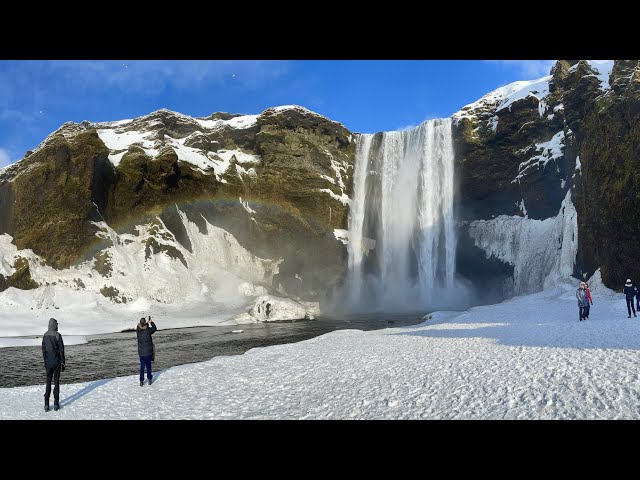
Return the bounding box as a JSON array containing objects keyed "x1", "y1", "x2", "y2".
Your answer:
[{"x1": 5, "y1": 131, "x2": 109, "y2": 268}]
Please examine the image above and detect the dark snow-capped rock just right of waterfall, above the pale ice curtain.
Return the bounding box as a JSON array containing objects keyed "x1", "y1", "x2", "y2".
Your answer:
[{"x1": 454, "y1": 70, "x2": 572, "y2": 220}]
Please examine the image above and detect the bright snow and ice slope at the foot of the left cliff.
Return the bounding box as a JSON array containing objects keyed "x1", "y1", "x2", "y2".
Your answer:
[{"x1": 0, "y1": 207, "x2": 281, "y2": 337}]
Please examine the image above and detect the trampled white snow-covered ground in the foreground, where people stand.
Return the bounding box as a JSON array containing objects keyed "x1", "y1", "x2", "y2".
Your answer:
[{"x1": 0, "y1": 274, "x2": 640, "y2": 419}]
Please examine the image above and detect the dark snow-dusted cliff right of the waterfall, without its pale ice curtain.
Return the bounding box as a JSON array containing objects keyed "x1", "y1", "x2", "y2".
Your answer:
[{"x1": 454, "y1": 60, "x2": 640, "y2": 293}]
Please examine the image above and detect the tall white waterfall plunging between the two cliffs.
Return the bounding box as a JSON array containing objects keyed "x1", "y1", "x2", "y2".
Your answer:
[{"x1": 347, "y1": 119, "x2": 456, "y2": 310}]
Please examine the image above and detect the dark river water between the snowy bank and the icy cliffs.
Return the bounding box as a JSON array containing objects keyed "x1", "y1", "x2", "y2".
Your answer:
[{"x1": 0, "y1": 315, "x2": 422, "y2": 387}]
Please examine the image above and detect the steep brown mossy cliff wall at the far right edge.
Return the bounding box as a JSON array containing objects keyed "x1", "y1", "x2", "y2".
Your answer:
[{"x1": 573, "y1": 60, "x2": 640, "y2": 284}]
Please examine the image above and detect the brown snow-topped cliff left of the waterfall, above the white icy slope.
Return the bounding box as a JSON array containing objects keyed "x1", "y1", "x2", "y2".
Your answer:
[{"x1": 0, "y1": 107, "x2": 355, "y2": 300}]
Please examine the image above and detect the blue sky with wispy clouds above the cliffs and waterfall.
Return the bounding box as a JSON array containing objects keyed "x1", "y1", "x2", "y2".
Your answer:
[{"x1": 0, "y1": 60, "x2": 553, "y2": 167}]
